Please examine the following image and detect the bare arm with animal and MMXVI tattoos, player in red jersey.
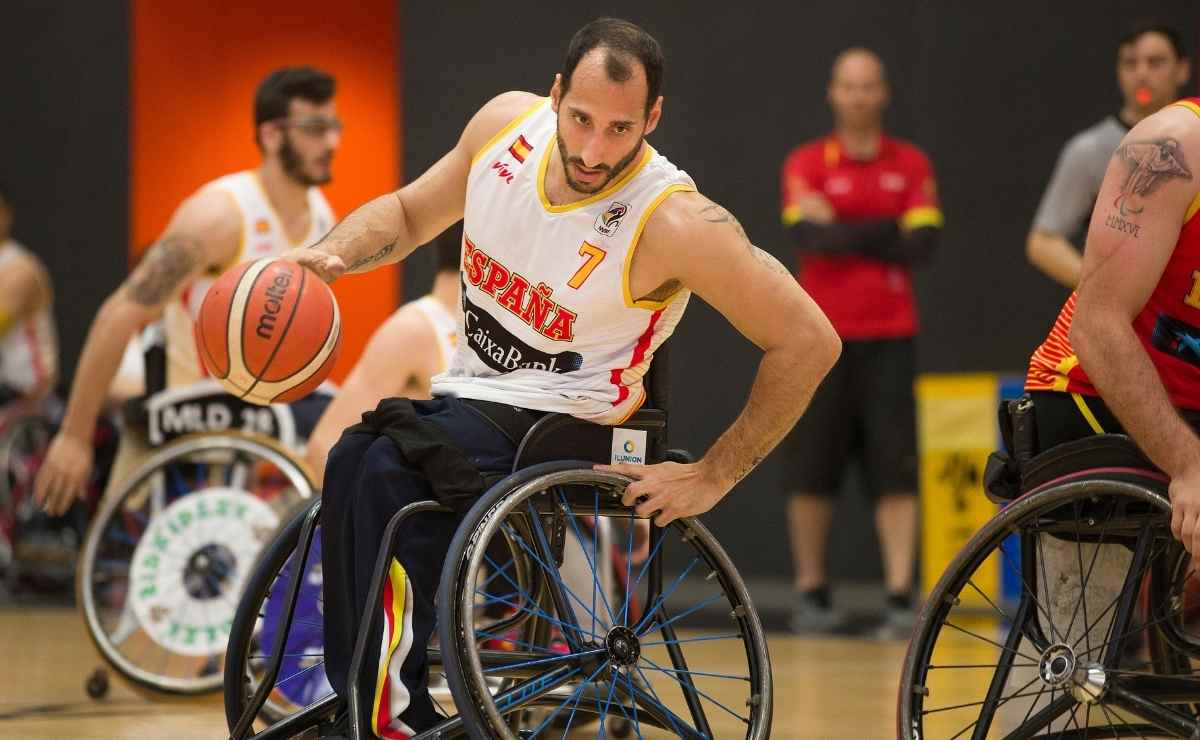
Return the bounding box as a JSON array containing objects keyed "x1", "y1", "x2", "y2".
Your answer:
[{"x1": 1070, "y1": 108, "x2": 1200, "y2": 554}]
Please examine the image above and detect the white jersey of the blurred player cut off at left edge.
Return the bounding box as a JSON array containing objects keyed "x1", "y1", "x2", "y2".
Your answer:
[{"x1": 0, "y1": 239, "x2": 59, "y2": 396}]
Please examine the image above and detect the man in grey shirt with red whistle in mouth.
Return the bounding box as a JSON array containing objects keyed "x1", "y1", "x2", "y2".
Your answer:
[{"x1": 1026, "y1": 25, "x2": 1192, "y2": 289}]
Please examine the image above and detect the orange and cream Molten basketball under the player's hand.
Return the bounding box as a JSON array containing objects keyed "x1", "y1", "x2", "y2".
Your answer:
[{"x1": 196, "y1": 258, "x2": 342, "y2": 404}]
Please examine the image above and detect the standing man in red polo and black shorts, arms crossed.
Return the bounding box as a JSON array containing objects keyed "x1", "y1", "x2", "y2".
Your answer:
[{"x1": 782, "y1": 48, "x2": 942, "y2": 636}]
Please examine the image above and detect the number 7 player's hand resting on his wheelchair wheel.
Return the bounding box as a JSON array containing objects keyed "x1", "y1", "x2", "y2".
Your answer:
[{"x1": 595, "y1": 462, "x2": 730, "y2": 527}]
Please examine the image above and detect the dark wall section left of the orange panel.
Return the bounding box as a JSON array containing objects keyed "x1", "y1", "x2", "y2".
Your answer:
[{"x1": 0, "y1": 0, "x2": 130, "y2": 379}]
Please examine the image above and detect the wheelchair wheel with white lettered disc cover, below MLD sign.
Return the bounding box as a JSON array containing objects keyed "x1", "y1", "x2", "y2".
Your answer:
[{"x1": 77, "y1": 433, "x2": 313, "y2": 694}]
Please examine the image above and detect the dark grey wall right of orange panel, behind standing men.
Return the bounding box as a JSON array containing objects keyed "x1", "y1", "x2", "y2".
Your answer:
[{"x1": 401, "y1": 0, "x2": 1200, "y2": 578}]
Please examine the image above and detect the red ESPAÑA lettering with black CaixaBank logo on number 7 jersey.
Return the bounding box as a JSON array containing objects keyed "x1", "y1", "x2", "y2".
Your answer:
[{"x1": 462, "y1": 239, "x2": 583, "y2": 373}]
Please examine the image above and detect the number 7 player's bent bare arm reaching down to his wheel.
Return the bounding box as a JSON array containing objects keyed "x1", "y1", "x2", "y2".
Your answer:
[{"x1": 602, "y1": 193, "x2": 841, "y2": 525}]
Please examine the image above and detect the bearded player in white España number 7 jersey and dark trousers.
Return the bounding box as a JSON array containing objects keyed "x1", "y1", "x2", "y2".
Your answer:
[{"x1": 293, "y1": 18, "x2": 840, "y2": 738}]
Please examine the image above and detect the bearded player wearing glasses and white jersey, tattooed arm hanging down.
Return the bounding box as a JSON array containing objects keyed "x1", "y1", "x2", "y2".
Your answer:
[{"x1": 36, "y1": 67, "x2": 342, "y2": 513}]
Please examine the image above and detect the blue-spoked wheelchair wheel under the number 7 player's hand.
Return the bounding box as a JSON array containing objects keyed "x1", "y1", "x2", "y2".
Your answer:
[{"x1": 438, "y1": 462, "x2": 772, "y2": 739}]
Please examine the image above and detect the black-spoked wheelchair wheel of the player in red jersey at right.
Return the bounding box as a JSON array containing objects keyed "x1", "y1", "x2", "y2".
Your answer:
[{"x1": 898, "y1": 480, "x2": 1200, "y2": 740}]
